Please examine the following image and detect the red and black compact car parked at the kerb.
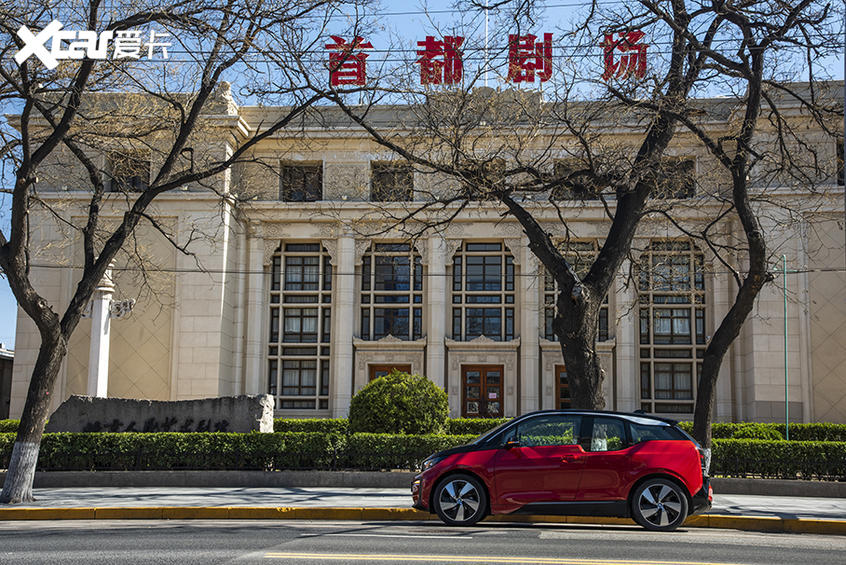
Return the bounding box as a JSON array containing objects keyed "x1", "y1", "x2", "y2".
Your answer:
[{"x1": 411, "y1": 410, "x2": 712, "y2": 531}]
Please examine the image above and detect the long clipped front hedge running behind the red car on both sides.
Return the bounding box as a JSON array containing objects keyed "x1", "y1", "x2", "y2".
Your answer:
[{"x1": 0, "y1": 432, "x2": 846, "y2": 480}]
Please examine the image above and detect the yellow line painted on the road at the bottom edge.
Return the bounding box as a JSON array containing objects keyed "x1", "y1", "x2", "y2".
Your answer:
[{"x1": 264, "y1": 552, "x2": 739, "y2": 565}]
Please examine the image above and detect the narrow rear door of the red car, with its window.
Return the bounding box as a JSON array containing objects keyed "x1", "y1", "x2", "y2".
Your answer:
[{"x1": 576, "y1": 416, "x2": 634, "y2": 501}]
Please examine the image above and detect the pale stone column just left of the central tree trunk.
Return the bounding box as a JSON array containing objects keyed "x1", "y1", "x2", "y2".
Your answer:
[{"x1": 519, "y1": 237, "x2": 543, "y2": 414}]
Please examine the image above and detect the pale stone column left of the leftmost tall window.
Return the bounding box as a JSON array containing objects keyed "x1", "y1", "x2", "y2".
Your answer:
[{"x1": 244, "y1": 222, "x2": 269, "y2": 394}]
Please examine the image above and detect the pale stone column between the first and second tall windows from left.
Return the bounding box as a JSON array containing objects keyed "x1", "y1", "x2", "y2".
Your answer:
[{"x1": 327, "y1": 233, "x2": 356, "y2": 418}]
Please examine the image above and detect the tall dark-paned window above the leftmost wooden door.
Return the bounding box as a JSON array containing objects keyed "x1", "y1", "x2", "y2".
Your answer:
[{"x1": 361, "y1": 243, "x2": 423, "y2": 340}]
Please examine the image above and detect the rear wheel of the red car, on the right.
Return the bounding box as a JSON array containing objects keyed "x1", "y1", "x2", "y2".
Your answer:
[{"x1": 631, "y1": 477, "x2": 688, "y2": 532}]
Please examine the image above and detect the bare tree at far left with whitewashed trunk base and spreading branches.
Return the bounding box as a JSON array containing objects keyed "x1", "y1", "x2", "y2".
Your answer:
[{"x1": 0, "y1": 0, "x2": 354, "y2": 503}]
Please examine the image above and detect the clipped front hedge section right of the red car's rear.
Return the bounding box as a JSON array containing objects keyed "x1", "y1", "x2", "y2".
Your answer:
[{"x1": 711, "y1": 439, "x2": 846, "y2": 481}]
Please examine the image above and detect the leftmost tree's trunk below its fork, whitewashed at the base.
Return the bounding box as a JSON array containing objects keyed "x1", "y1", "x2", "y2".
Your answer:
[{"x1": 0, "y1": 332, "x2": 67, "y2": 504}]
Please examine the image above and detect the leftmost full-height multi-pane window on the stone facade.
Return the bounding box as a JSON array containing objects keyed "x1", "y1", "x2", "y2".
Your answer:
[{"x1": 267, "y1": 243, "x2": 332, "y2": 410}]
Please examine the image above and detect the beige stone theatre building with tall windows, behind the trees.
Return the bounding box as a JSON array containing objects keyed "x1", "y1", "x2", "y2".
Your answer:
[{"x1": 11, "y1": 85, "x2": 846, "y2": 422}]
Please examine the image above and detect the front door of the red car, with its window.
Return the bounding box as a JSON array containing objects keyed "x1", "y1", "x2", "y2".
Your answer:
[{"x1": 492, "y1": 414, "x2": 585, "y2": 512}]
